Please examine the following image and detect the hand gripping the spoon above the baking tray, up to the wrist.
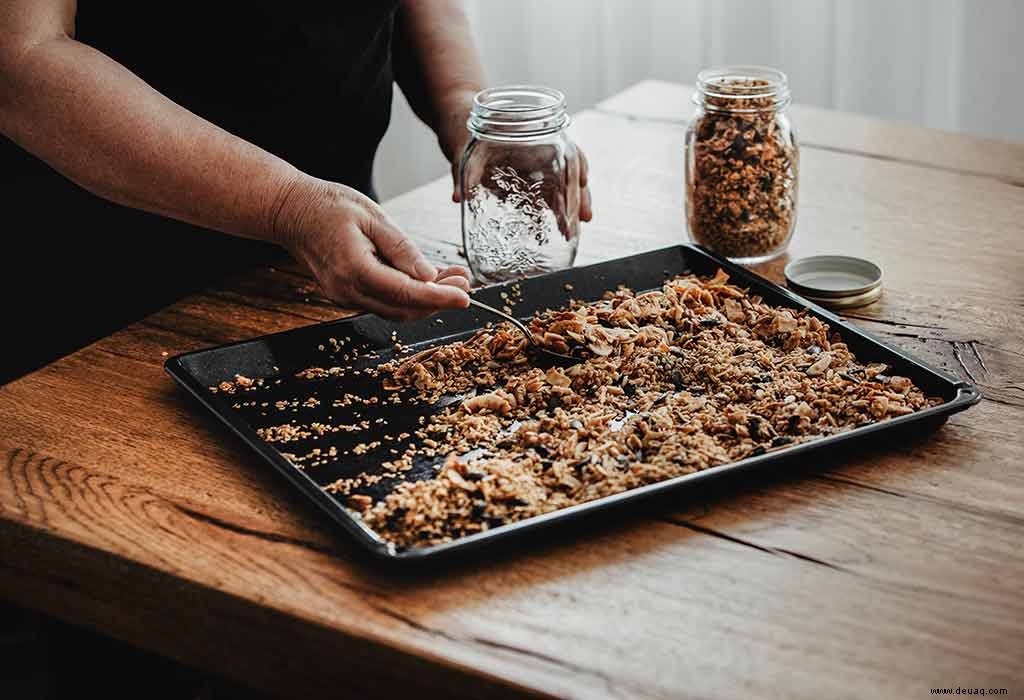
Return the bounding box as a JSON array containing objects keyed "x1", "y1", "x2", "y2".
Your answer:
[{"x1": 271, "y1": 176, "x2": 470, "y2": 320}]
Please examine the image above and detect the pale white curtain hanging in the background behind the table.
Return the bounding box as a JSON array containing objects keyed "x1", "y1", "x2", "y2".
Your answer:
[{"x1": 377, "y1": 0, "x2": 1024, "y2": 199}]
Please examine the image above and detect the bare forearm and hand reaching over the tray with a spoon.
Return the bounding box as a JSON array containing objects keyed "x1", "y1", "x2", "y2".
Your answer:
[{"x1": 0, "y1": 0, "x2": 468, "y2": 318}]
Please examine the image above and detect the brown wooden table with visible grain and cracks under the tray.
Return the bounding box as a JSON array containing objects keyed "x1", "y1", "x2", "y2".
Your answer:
[{"x1": 0, "y1": 82, "x2": 1024, "y2": 698}]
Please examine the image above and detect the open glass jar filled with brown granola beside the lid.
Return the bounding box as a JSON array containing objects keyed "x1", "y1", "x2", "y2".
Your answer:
[{"x1": 686, "y1": 65, "x2": 800, "y2": 264}]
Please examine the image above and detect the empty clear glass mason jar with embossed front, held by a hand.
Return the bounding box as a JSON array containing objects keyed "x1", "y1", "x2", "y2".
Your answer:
[{"x1": 459, "y1": 85, "x2": 580, "y2": 283}]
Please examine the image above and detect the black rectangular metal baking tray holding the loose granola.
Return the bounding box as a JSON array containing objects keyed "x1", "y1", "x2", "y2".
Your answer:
[{"x1": 165, "y1": 246, "x2": 981, "y2": 561}]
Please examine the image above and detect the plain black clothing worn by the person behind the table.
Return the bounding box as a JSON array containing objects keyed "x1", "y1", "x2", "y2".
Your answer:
[{"x1": 0, "y1": 0, "x2": 397, "y2": 383}]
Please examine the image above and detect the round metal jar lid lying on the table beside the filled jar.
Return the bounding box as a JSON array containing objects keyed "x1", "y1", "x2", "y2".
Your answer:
[{"x1": 785, "y1": 255, "x2": 882, "y2": 308}]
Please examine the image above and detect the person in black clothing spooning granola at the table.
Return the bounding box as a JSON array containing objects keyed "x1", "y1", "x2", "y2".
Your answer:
[{"x1": 0, "y1": 0, "x2": 589, "y2": 382}]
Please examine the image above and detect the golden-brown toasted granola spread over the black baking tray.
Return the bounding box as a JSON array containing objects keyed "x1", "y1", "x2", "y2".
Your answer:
[{"x1": 362, "y1": 270, "x2": 941, "y2": 546}]
